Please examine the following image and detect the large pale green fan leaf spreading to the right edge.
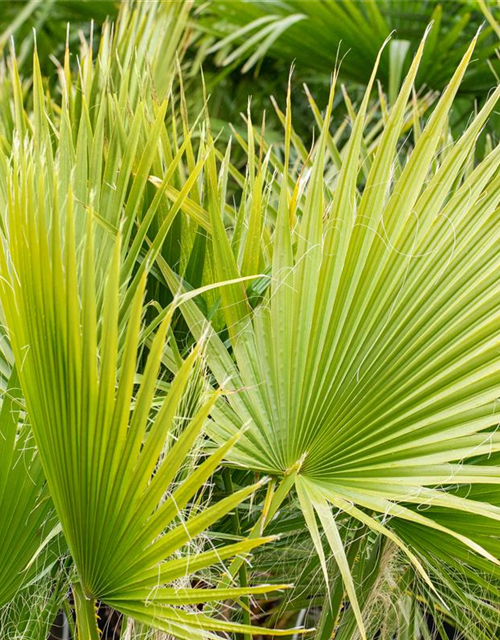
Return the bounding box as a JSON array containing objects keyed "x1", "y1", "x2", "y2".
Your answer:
[{"x1": 170, "y1": 33, "x2": 500, "y2": 629}]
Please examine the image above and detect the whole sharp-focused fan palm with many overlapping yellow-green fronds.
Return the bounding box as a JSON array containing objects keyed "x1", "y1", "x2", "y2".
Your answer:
[{"x1": 0, "y1": 2, "x2": 500, "y2": 640}]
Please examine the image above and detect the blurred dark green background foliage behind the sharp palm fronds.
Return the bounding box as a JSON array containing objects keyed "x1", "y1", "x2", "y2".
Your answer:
[{"x1": 195, "y1": 0, "x2": 500, "y2": 134}]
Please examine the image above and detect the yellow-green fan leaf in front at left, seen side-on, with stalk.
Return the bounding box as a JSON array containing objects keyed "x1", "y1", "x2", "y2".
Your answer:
[{"x1": 0, "y1": 131, "x2": 306, "y2": 639}]
